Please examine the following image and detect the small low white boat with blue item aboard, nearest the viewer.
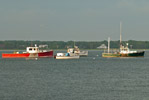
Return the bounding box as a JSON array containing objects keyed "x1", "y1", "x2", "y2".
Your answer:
[{"x1": 55, "y1": 53, "x2": 80, "y2": 59}]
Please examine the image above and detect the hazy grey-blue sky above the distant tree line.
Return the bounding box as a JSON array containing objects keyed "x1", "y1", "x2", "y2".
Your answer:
[{"x1": 0, "y1": 0, "x2": 149, "y2": 41}]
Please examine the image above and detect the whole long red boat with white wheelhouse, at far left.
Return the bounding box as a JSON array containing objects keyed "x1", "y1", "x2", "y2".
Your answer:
[{"x1": 2, "y1": 45, "x2": 53, "y2": 58}]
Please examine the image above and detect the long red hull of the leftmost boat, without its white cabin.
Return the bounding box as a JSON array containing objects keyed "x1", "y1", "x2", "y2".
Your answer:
[{"x1": 2, "y1": 51, "x2": 53, "y2": 58}]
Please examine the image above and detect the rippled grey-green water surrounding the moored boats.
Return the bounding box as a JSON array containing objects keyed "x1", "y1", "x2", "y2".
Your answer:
[{"x1": 0, "y1": 51, "x2": 149, "y2": 100}]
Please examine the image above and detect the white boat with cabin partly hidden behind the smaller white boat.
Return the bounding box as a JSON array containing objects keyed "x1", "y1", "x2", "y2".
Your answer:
[{"x1": 67, "y1": 46, "x2": 88, "y2": 57}]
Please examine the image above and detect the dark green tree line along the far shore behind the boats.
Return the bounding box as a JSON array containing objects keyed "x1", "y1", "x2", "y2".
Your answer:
[{"x1": 0, "y1": 40, "x2": 149, "y2": 50}]
